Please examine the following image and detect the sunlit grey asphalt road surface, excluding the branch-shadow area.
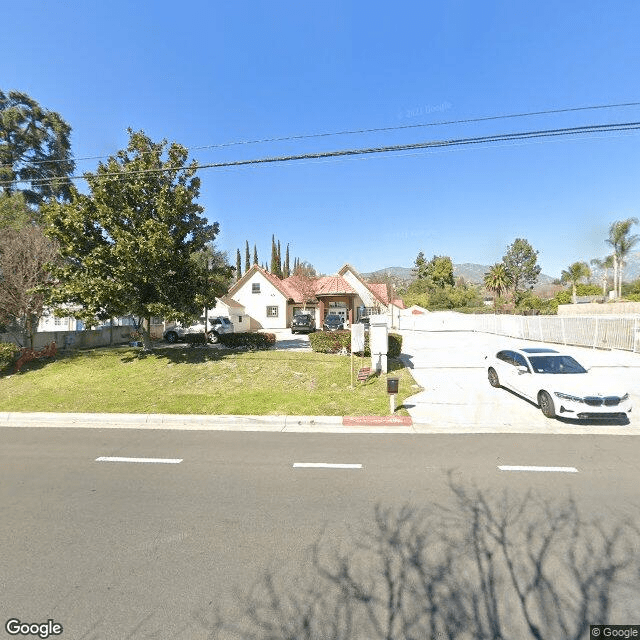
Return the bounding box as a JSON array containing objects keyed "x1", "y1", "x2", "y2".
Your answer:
[{"x1": 0, "y1": 428, "x2": 640, "y2": 640}]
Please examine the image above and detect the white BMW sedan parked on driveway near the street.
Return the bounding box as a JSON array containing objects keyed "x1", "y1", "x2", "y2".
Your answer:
[{"x1": 487, "y1": 347, "x2": 631, "y2": 419}]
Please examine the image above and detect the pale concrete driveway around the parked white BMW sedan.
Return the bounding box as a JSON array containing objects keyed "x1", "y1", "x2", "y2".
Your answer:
[{"x1": 400, "y1": 331, "x2": 640, "y2": 432}]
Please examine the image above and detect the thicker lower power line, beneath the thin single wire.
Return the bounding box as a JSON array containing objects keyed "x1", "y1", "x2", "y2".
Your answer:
[{"x1": 0, "y1": 122, "x2": 640, "y2": 186}]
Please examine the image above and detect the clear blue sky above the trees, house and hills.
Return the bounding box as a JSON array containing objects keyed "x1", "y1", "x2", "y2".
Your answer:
[{"x1": 5, "y1": 0, "x2": 640, "y2": 277}]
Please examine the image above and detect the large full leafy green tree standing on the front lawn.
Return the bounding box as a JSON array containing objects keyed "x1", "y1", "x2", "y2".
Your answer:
[{"x1": 43, "y1": 130, "x2": 218, "y2": 350}]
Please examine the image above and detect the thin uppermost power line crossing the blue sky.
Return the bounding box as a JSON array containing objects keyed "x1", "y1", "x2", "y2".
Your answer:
[{"x1": 0, "y1": 102, "x2": 640, "y2": 168}]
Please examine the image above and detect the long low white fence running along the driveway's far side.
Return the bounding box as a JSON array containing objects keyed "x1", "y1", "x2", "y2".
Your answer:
[{"x1": 399, "y1": 311, "x2": 640, "y2": 353}]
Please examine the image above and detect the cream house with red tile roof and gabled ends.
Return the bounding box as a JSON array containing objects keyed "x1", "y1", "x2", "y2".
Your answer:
[{"x1": 225, "y1": 264, "x2": 404, "y2": 330}]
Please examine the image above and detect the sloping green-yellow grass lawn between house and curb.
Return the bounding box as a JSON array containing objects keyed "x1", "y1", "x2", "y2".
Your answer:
[{"x1": 0, "y1": 347, "x2": 420, "y2": 416}]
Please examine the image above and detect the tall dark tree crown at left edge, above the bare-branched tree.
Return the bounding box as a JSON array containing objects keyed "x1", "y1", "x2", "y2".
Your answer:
[{"x1": 0, "y1": 91, "x2": 75, "y2": 205}]
